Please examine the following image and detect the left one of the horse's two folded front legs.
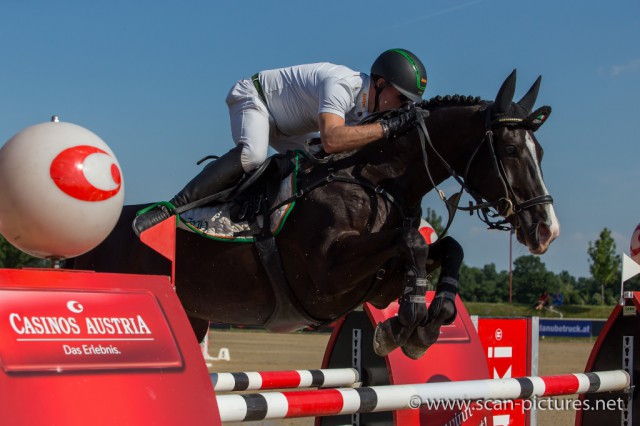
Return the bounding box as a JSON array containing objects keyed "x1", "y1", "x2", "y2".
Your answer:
[{"x1": 373, "y1": 228, "x2": 428, "y2": 356}]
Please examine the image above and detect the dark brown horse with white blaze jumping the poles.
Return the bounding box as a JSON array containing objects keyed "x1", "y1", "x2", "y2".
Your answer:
[{"x1": 68, "y1": 70, "x2": 559, "y2": 359}]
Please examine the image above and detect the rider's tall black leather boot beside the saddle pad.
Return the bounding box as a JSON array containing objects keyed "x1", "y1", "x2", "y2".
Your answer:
[{"x1": 133, "y1": 145, "x2": 244, "y2": 236}]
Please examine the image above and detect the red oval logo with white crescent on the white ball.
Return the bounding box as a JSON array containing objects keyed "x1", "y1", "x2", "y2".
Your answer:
[{"x1": 49, "y1": 145, "x2": 122, "y2": 201}]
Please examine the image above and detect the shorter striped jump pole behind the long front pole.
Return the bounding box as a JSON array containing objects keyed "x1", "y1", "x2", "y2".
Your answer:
[{"x1": 209, "y1": 368, "x2": 360, "y2": 392}]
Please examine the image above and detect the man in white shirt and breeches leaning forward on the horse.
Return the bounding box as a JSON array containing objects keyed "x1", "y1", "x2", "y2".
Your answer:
[{"x1": 133, "y1": 49, "x2": 427, "y2": 235}]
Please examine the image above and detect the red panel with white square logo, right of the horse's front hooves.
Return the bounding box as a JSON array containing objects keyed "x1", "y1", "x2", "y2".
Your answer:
[{"x1": 478, "y1": 318, "x2": 532, "y2": 426}]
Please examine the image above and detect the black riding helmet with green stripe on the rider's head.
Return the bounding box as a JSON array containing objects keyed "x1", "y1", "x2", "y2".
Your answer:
[{"x1": 371, "y1": 49, "x2": 427, "y2": 102}]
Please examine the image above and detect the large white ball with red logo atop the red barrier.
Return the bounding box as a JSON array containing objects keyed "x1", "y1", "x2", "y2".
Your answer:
[{"x1": 0, "y1": 121, "x2": 124, "y2": 258}]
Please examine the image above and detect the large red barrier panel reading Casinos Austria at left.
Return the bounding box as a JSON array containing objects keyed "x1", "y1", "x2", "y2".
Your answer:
[{"x1": 0, "y1": 269, "x2": 220, "y2": 426}]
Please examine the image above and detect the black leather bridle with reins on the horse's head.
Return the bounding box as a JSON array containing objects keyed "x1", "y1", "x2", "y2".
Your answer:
[{"x1": 415, "y1": 107, "x2": 553, "y2": 235}]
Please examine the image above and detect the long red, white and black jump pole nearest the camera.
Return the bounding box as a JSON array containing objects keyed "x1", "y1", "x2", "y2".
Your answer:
[{"x1": 216, "y1": 370, "x2": 630, "y2": 422}]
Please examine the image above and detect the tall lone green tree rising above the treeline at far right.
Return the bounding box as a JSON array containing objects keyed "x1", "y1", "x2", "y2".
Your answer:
[{"x1": 587, "y1": 228, "x2": 621, "y2": 304}]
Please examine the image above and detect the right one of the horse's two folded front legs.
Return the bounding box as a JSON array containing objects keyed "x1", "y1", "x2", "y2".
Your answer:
[{"x1": 402, "y1": 237, "x2": 464, "y2": 359}]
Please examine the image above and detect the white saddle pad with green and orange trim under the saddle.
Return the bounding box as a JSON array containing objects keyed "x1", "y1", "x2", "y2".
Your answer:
[{"x1": 178, "y1": 173, "x2": 296, "y2": 242}]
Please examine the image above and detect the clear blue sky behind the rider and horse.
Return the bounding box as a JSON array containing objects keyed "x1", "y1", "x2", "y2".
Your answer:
[{"x1": 0, "y1": 0, "x2": 640, "y2": 276}]
